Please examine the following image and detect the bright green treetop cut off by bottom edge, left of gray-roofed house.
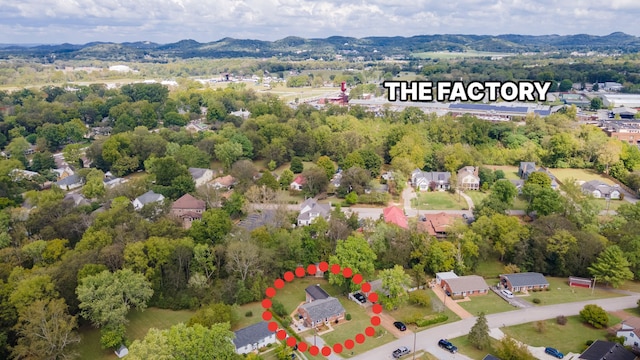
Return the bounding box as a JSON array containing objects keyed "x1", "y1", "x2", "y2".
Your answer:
[{"x1": 127, "y1": 323, "x2": 237, "y2": 360}]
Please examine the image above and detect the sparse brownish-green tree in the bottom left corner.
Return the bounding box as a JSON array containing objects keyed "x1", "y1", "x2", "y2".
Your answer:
[{"x1": 12, "y1": 299, "x2": 80, "y2": 359}]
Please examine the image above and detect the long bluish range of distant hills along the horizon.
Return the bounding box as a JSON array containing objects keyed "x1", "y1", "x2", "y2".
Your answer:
[{"x1": 0, "y1": 32, "x2": 640, "y2": 62}]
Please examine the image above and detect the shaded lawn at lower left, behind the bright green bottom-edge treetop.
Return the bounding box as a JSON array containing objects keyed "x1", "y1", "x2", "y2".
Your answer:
[{"x1": 78, "y1": 308, "x2": 194, "y2": 360}]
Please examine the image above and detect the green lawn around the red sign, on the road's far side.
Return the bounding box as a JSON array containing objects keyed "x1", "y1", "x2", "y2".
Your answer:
[{"x1": 524, "y1": 277, "x2": 622, "y2": 306}]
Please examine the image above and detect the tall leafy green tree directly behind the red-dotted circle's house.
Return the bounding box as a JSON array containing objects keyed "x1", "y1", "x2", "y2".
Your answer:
[{"x1": 329, "y1": 236, "x2": 377, "y2": 290}]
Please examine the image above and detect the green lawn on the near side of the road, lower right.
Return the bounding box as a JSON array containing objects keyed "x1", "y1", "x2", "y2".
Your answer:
[{"x1": 501, "y1": 315, "x2": 620, "y2": 354}]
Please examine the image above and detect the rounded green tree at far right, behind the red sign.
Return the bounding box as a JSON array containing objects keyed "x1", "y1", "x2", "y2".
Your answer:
[{"x1": 589, "y1": 245, "x2": 633, "y2": 287}]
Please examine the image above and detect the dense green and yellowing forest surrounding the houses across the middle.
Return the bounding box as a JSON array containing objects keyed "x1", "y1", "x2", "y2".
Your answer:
[{"x1": 0, "y1": 83, "x2": 640, "y2": 358}]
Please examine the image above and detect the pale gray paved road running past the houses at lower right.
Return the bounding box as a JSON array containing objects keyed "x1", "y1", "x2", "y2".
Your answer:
[{"x1": 352, "y1": 294, "x2": 640, "y2": 360}]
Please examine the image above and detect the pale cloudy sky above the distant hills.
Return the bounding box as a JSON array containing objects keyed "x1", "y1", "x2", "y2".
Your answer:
[{"x1": 0, "y1": 0, "x2": 640, "y2": 44}]
